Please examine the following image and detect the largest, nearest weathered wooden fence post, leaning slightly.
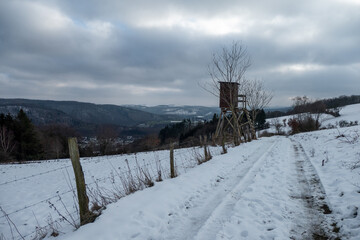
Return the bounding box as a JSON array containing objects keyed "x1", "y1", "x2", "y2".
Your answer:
[{"x1": 68, "y1": 138, "x2": 95, "y2": 225}]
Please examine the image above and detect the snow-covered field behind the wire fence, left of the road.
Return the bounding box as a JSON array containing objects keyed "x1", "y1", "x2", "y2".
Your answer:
[{"x1": 0, "y1": 147, "x2": 220, "y2": 239}]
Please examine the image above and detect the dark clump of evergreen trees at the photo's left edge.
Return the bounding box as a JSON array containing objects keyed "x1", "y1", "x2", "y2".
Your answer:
[{"x1": 0, "y1": 109, "x2": 76, "y2": 162}]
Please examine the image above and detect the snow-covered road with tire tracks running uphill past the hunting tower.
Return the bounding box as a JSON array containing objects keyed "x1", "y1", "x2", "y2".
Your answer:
[{"x1": 60, "y1": 137, "x2": 342, "y2": 240}]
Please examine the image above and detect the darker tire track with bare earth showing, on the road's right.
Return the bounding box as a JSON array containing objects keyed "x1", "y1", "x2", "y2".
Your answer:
[{"x1": 290, "y1": 139, "x2": 340, "y2": 240}]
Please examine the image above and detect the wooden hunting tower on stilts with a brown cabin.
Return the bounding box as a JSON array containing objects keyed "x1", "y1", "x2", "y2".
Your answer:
[{"x1": 215, "y1": 82, "x2": 256, "y2": 143}]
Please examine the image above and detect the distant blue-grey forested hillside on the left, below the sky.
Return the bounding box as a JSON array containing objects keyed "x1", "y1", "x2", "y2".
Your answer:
[{"x1": 0, "y1": 99, "x2": 172, "y2": 127}]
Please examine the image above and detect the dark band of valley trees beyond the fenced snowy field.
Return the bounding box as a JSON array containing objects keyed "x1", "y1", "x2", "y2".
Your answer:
[{"x1": 0, "y1": 110, "x2": 266, "y2": 162}]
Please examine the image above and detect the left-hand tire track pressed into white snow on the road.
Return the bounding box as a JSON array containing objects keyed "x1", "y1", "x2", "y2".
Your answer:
[{"x1": 167, "y1": 141, "x2": 277, "y2": 240}]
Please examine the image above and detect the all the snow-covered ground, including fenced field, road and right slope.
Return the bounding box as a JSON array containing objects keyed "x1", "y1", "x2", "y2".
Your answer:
[{"x1": 0, "y1": 104, "x2": 360, "y2": 240}]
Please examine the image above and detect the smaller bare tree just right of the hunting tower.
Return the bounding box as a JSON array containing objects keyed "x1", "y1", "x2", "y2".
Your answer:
[{"x1": 243, "y1": 79, "x2": 273, "y2": 121}]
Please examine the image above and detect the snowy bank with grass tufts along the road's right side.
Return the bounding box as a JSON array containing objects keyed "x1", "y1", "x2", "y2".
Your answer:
[{"x1": 293, "y1": 127, "x2": 360, "y2": 239}]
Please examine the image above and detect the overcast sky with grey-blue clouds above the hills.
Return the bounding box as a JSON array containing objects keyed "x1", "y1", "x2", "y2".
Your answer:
[{"x1": 0, "y1": 0, "x2": 360, "y2": 106}]
